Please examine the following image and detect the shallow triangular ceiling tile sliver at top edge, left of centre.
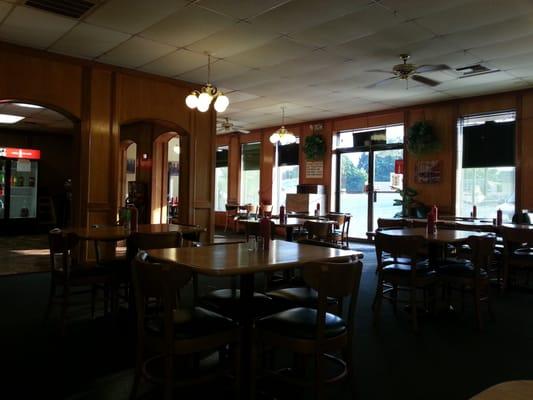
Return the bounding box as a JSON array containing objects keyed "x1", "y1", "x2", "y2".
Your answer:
[{"x1": 195, "y1": 0, "x2": 287, "y2": 19}]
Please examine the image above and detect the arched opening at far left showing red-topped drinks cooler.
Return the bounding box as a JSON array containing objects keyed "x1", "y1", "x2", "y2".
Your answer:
[{"x1": 0, "y1": 99, "x2": 81, "y2": 232}]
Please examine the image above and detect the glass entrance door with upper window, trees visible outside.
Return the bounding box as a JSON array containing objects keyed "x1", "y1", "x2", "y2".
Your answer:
[{"x1": 332, "y1": 125, "x2": 404, "y2": 239}]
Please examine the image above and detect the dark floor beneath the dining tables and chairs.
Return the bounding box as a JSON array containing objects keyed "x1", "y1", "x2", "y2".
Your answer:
[{"x1": 0, "y1": 233, "x2": 533, "y2": 400}]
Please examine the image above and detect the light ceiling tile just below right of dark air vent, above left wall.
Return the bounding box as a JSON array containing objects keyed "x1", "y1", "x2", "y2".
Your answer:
[{"x1": 50, "y1": 22, "x2": 130, "y2": 58}]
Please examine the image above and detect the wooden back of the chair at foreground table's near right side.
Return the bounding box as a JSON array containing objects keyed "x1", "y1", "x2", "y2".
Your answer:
[{"x1": 302, "y1": 256, "x2": 363, "y2": 340}]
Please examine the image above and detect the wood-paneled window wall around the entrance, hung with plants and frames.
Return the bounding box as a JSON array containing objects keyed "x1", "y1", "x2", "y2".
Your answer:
[{"x1": 217, "y1": 89, "x2": 533, "y2": 224}]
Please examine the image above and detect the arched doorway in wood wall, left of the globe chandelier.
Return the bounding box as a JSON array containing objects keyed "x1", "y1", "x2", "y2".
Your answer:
[{"x1": 119, "y1": 120, "x2": 190, "y2": 223}]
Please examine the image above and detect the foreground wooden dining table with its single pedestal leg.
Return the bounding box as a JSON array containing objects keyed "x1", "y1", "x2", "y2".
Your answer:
[{"x1": 148, "y1": 240, "x2": 363, "y2": 398}]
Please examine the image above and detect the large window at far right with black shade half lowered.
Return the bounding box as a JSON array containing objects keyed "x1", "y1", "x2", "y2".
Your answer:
[{"x1": 456, "y1": 111, "x2": 516, "y2": 222}]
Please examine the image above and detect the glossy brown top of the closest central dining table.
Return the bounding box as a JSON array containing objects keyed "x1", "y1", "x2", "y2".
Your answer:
[{"x1": 148, "y1": 240, "x2": 363, "y2": 276}]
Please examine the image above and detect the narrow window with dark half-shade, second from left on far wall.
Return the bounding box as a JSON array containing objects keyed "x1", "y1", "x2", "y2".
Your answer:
[{"x1": 240, "y1": 143, "x2": 261, "y2": 204}]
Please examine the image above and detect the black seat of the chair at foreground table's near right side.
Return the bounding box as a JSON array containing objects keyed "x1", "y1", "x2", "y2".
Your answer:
[{"x1": 256, "y1": 307, "x2": 347, "y2": 340}]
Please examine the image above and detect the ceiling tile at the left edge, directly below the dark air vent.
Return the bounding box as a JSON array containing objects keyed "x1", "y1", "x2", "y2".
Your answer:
[{"x1": 0, "y1": 6, "x2": 78, "y2": 49}]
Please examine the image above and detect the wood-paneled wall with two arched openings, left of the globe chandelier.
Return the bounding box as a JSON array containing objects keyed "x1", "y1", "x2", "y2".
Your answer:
[{"x1": 0, "y1": 43, "x2": 215, "y2": 239}]
